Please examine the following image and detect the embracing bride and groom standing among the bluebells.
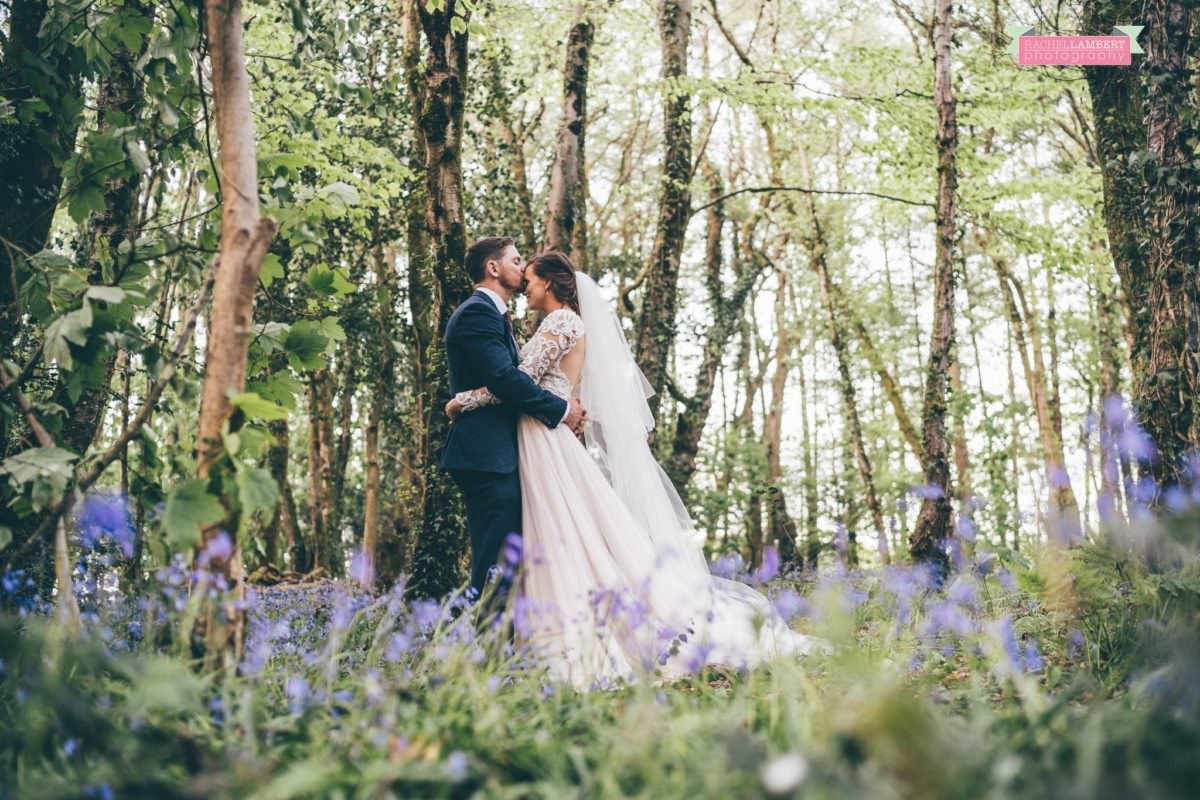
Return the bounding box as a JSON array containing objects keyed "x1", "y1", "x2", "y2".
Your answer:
[{"x1": 438, "y1": 236, "x2": 823, "y2": 688}]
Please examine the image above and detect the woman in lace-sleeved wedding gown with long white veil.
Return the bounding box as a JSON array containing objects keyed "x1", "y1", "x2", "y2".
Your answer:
[{"x1": 446, "y1": 252, "x2": 824, "y2": 688}]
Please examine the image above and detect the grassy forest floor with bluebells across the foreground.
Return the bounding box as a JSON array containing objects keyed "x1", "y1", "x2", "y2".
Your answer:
[{"x1": 0, "y1": 520, "x2": 1200, "y2": 799}]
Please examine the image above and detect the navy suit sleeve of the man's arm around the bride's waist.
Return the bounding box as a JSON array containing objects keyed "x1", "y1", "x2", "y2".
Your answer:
[{"x1": 454, "y1": 305, "x2": 568, "y2": 428}]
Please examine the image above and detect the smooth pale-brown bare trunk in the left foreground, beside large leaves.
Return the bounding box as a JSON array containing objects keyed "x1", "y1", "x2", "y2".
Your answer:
[{"x1": 197, "y1": 0, "x2": 275, "y2": 666}]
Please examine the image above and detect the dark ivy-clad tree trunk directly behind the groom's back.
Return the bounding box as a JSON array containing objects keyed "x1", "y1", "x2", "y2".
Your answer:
[{"x1": 410, "y1": 0, "x2": 470, "y2": 597}]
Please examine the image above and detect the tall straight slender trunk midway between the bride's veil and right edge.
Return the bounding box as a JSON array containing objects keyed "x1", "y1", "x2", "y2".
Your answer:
[{"x1": 910, "y1": 0, "x2": 959, "y2": 577}]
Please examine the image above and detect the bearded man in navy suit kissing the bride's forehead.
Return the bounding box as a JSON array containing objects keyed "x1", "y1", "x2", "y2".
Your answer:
[{"x1": 438, "y1": 236, "x2": 587, "y2": 602}]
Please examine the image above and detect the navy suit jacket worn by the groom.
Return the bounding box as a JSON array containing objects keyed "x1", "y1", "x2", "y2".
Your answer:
[{"x1": 438, "y1": 291, "x2": 566, "y2": 474}]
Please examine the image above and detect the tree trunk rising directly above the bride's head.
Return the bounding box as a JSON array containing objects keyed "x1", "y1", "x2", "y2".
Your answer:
[{"x1": 542, "y1": 2, "x2": 595, "y2": 267}]
